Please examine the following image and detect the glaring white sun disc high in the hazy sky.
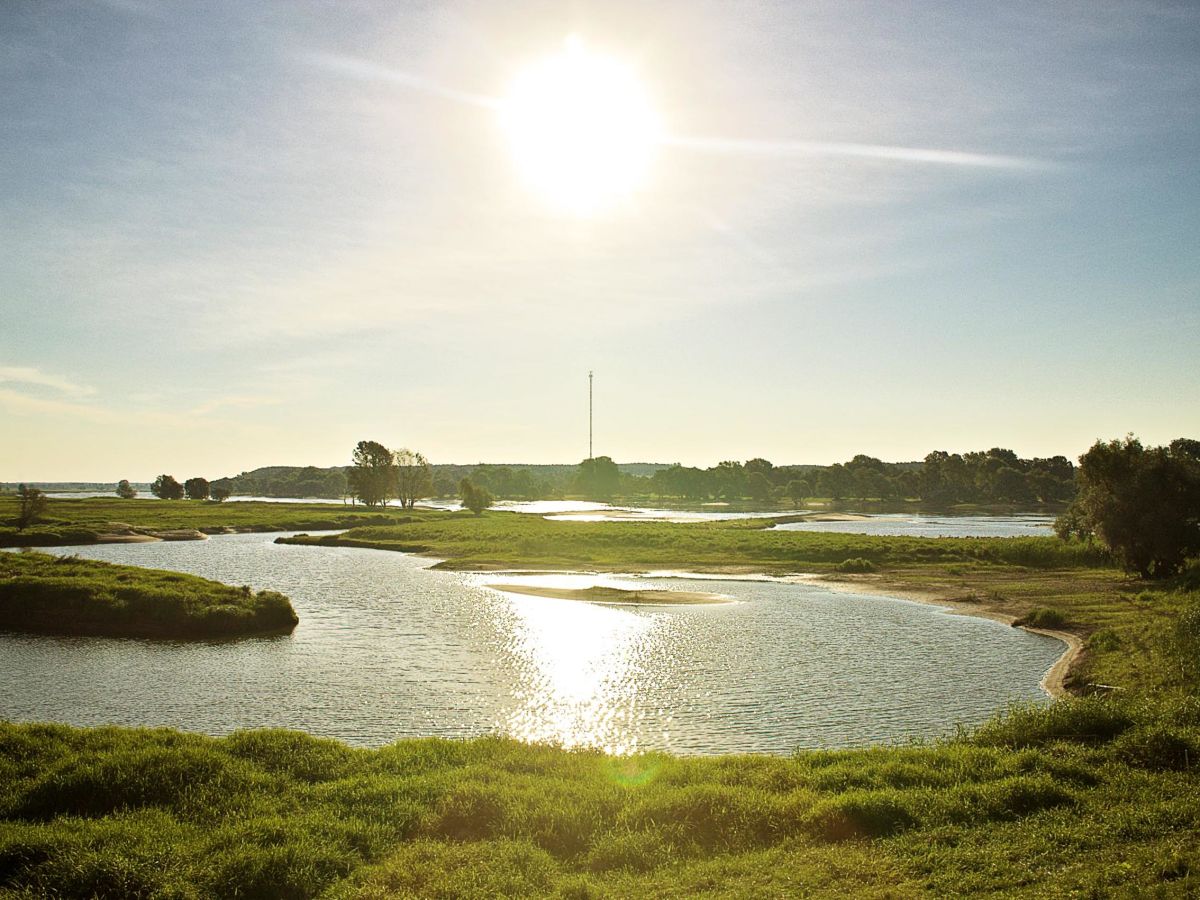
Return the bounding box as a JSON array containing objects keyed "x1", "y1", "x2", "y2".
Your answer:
[{"x1": 499, "y1": 37, "x2": 661, "y2": 216}]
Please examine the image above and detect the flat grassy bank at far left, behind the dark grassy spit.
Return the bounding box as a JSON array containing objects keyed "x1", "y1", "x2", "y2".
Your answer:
[{"x1": 0, "y1": 497, "x2": 429, "y2": 547}]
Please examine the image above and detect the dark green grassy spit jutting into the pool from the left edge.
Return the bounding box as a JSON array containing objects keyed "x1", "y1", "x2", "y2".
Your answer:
[{"x1": 0, "y1": 551, "x2": 299, "y2": 643}]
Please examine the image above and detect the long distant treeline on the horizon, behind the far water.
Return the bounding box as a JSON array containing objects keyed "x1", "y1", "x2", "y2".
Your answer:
[{"x1": 212, "y1": 448, "x2": 1075, "y2": 505}]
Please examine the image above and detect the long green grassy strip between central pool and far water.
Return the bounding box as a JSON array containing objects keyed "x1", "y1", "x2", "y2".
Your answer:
[{"x1": 280, "y1": 512, "x2": 1108, "y2": 572}]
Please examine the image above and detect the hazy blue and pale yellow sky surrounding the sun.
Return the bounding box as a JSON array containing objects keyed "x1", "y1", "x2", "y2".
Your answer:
[{"x1": 0, "y1": 0, "x2": 1200, "y2": 481}]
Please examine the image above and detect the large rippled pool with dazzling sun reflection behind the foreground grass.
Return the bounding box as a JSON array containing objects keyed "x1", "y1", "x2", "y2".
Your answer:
[{"x1": 0, "y1": 534, "x2": 1062, "y2": 754}]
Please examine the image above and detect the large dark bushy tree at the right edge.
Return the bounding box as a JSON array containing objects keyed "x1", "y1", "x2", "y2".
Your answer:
[{"x1": 1055, "y1": 434, "x2": 1200, "y2": 578}]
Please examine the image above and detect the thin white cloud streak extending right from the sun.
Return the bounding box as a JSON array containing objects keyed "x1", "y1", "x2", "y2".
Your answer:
[{"x1": 664, "y1": 137, "x2": 1055, "y2": 170}]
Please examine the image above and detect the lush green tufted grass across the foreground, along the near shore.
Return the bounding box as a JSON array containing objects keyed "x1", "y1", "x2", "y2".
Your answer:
[{"x1": 0, "y1": 700, "x2": 1200, "y2": 898}]
